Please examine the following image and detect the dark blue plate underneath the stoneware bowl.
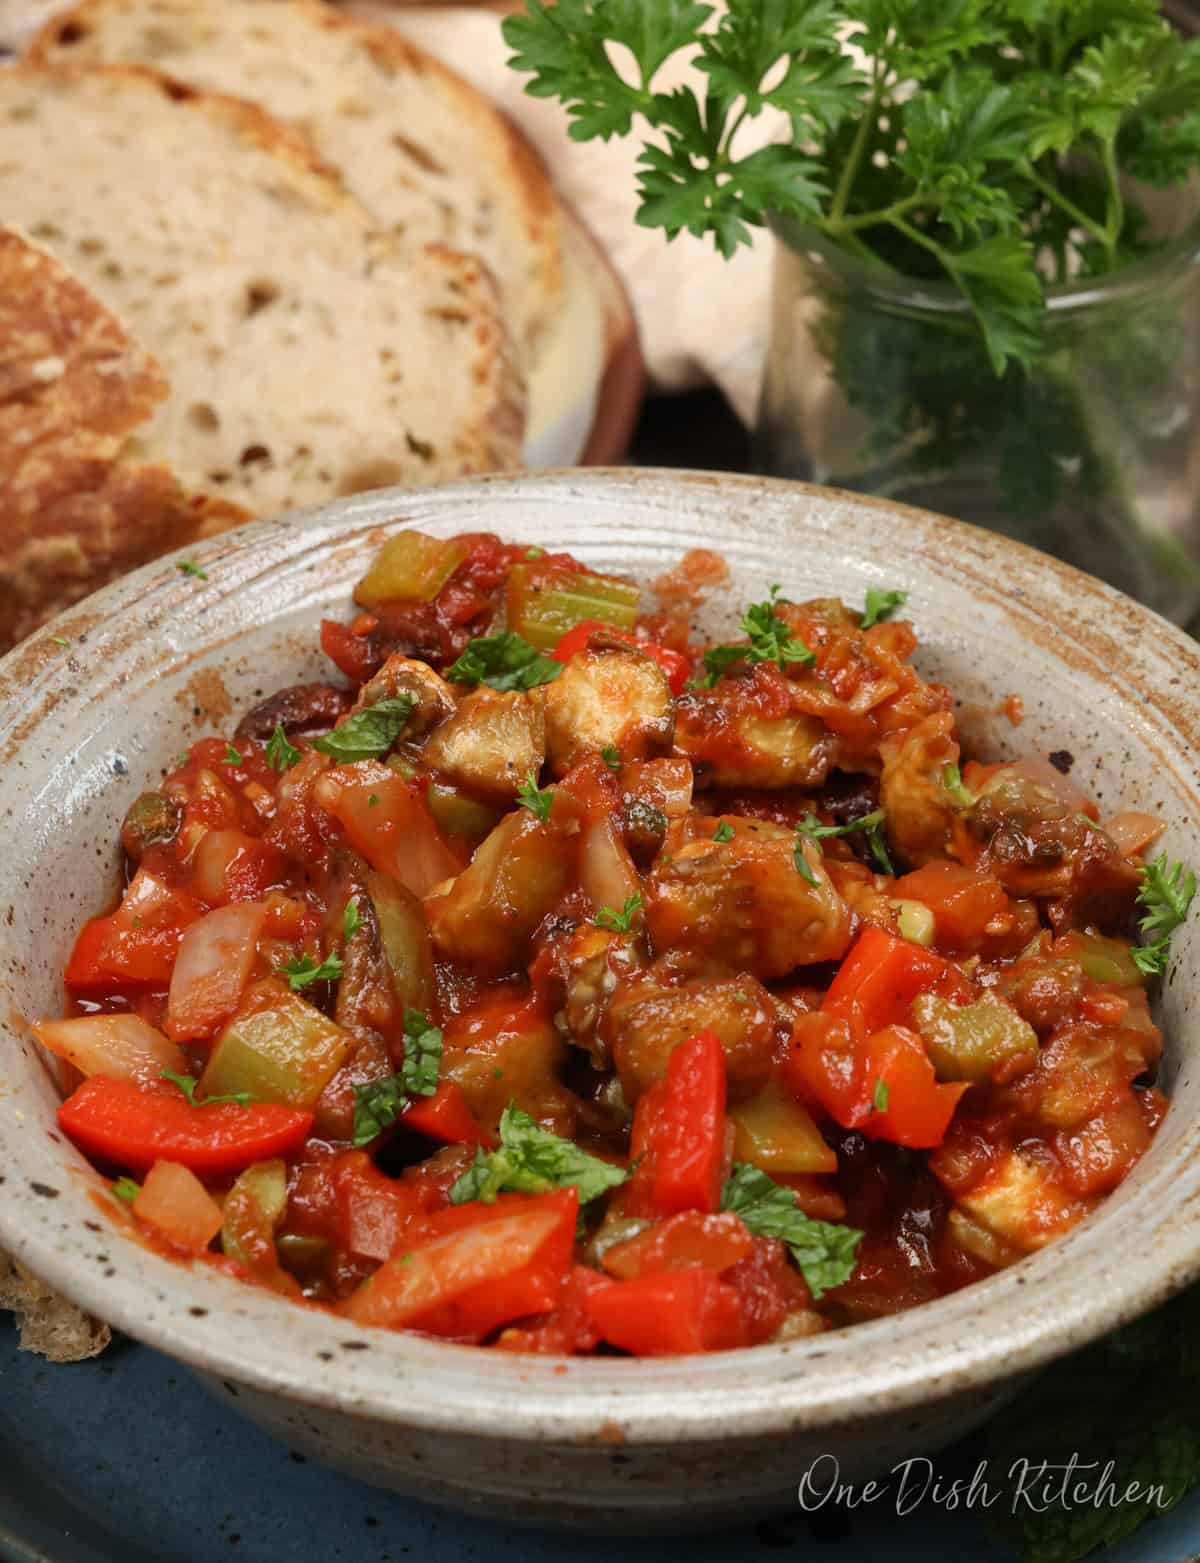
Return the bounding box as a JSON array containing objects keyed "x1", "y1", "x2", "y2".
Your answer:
[{"x1": 0, "y1": 1319, "x2": 1200, "y2": 1563}]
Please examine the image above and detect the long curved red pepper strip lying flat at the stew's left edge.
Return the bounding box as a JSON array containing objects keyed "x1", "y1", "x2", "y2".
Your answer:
[{"x1": 58, "y1": 1075, "x2": 313, "y2": 1179}]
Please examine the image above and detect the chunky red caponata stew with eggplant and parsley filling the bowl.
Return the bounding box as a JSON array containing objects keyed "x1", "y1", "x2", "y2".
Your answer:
[{"x1": 34, "y1": 531, "x2": 1195, "y2": 1355}]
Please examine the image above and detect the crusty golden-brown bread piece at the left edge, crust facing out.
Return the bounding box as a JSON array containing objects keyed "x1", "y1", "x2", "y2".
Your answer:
[{"x1": 0, "y1": 228, "x2": 245, "y2": 650}]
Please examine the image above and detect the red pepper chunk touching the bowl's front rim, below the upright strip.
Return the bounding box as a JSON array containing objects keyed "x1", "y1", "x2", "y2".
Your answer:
[{"x1": 588, "y1": 1264, "x2": 745, "y2": 1357}]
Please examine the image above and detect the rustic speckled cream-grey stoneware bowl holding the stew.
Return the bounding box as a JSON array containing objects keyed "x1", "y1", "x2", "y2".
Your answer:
[{"x1": 0, "y1": 470, "x2": 1200, "y2": 1530}]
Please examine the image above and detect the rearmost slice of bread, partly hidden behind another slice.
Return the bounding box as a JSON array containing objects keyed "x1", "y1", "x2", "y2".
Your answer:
[{"x1": 30, "y1": 0, "x2": 564, "y2": 366}]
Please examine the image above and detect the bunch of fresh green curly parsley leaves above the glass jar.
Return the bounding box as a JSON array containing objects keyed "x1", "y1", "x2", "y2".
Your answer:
[{"x1": 505, "y1": 0, "x2": 1200, "y2": 375}]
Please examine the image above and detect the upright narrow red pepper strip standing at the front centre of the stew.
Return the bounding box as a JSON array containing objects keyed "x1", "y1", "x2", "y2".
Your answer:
[{"x1": 627, "y1": 1030, "x2": 725, "y2": 1216}]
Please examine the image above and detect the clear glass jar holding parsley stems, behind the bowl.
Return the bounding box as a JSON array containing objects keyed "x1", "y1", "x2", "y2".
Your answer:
[{"x1": 756, "y1": 212, "x2": 1200, "y2": 624}]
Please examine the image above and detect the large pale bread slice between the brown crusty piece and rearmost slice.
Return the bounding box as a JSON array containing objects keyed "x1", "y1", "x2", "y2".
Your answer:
[{"x1": 0, "y1": 66, "x2": 523, "y2": 514}]
